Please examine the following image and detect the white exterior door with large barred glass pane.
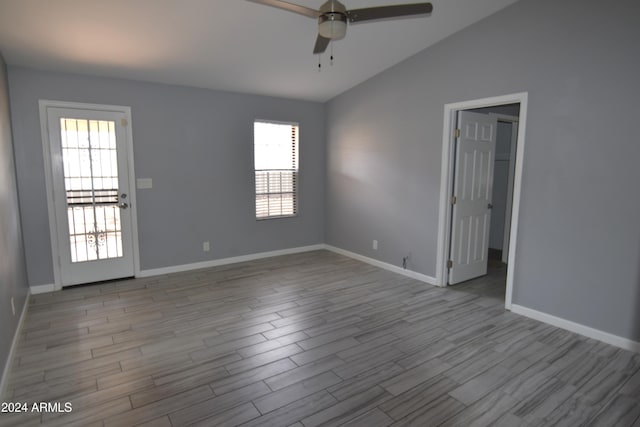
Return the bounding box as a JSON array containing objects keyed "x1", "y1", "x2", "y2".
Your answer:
[{"x1": 46, "y1": 106, "x2": 135, "y2": 286}]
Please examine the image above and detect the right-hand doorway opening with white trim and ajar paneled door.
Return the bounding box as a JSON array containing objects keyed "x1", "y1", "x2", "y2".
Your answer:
[{"x1": 436, "y1": 93, "x2": 527, "y2": 310}]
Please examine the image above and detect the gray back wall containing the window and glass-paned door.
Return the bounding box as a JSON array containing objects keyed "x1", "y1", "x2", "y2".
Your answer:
[{"x1": 9, "y1": 67, "x2": 325, "y2": 285}]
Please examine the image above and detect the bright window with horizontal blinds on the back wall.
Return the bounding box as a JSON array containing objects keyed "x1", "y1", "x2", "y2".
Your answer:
[{"x1": 253, "y1": 121, "x2": 299, "y2": 219}]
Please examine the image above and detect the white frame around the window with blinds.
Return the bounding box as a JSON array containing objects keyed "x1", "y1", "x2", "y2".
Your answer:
[{"x1": 253, "y1": 119, "x2": 300, "y2": 221}]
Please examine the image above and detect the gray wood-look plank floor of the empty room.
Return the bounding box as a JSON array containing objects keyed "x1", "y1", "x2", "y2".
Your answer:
[{"x1": 0, "y1": 251, "x2": 640, "y2": 427}]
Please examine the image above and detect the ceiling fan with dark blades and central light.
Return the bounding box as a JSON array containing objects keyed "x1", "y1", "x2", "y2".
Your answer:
[{"x1": 247, "y1": 0, "x2": 433, "y2": 54}]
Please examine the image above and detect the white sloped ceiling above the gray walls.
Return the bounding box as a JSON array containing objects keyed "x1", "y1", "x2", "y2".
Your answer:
[{"x1": 0, "y1": 0, "x2": 517, "y2": 101}]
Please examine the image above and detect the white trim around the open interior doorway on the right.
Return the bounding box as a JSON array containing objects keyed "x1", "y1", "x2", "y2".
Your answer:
[{"x1": 436, "y1": 92, "x2": 528, "y2": 310}]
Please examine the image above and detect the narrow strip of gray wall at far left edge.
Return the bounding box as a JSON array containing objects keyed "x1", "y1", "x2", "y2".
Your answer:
[{"x1": 0, "y1": 56, "x2": 28, "y2": 377}]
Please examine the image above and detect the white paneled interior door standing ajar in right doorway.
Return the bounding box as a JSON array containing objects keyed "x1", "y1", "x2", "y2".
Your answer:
[{"x1": 449, "y1": 111, "x2": 497, "y2": 285}]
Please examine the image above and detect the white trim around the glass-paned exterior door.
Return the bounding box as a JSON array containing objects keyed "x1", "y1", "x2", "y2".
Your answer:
[{"x1": 38, "y1": 99, "x2": 140, "y2": 290}]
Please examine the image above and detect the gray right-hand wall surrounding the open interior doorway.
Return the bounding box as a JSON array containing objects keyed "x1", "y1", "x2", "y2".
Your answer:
[{"x1": 327, "y1": 0, "x2": 640, "y2": 341}]
